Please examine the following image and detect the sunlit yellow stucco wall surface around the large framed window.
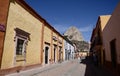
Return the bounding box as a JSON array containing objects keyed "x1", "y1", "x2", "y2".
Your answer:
[{"x1": 2, "y1": 3, "x2": 42, "y2": 69}]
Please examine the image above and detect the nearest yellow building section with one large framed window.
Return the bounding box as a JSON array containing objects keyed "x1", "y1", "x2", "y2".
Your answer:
[{"x1": 1, "y1": 0, "x2": 43, "y2": 69}]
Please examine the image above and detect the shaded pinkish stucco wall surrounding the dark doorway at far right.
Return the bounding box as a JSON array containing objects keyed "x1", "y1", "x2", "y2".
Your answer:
[{"x1": 103, "y1": 3, "x2": 120, "y2": 64}]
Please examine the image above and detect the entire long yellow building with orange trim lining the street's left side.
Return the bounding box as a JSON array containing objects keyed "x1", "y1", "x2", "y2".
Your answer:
[{"x1": 0, "y1": 0, "x2": 64, "y2": 75}]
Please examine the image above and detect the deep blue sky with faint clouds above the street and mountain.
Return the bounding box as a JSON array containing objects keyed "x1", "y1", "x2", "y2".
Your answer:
[{"x1": 25, "y1": 0, "x2": 120, "y2": 42}]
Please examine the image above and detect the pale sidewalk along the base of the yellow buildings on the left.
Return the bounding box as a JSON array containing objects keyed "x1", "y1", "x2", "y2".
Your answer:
[{"x1": 5, "y1": 60, "x2": 71, "y2": 76}]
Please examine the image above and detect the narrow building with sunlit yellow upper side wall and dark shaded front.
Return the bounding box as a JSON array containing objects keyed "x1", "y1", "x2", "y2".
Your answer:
[{"x1": 90, "y1": 15, "x2": 111, "y2": 65}]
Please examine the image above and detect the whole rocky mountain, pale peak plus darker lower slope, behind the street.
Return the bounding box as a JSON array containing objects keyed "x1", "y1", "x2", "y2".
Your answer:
[{"x1": 64, "y1": 26, "x2": 89, "y2": 51}]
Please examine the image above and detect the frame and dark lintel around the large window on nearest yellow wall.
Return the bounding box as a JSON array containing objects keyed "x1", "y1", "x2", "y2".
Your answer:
[{"x1": 13, "y1": 28, "x2": 30, "y2": 66}]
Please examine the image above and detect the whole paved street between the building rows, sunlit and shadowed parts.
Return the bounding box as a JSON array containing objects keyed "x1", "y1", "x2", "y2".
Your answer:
[{"x1": 6, "y1": 59, "x2": 113, "y2": 76}]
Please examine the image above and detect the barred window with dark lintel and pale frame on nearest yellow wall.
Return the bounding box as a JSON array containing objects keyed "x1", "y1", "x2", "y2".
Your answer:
[{"x1": 14, "y1": 28, "x2": 30, "y2": 56}]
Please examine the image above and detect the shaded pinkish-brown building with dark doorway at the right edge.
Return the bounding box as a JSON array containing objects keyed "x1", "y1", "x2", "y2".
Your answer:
[{"x1": 103, "y1": 3, "x2": 120, "y2": 76}]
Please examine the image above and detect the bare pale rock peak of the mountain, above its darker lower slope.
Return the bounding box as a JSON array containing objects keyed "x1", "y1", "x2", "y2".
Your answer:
[{"x1": 64, "y1": 26, "x2": 84, "y2": 41}]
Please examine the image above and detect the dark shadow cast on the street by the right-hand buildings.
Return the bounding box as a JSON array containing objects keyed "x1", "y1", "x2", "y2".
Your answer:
[{"x1": 80, "y1": 57, "x2": 114, "y2": 76}]
